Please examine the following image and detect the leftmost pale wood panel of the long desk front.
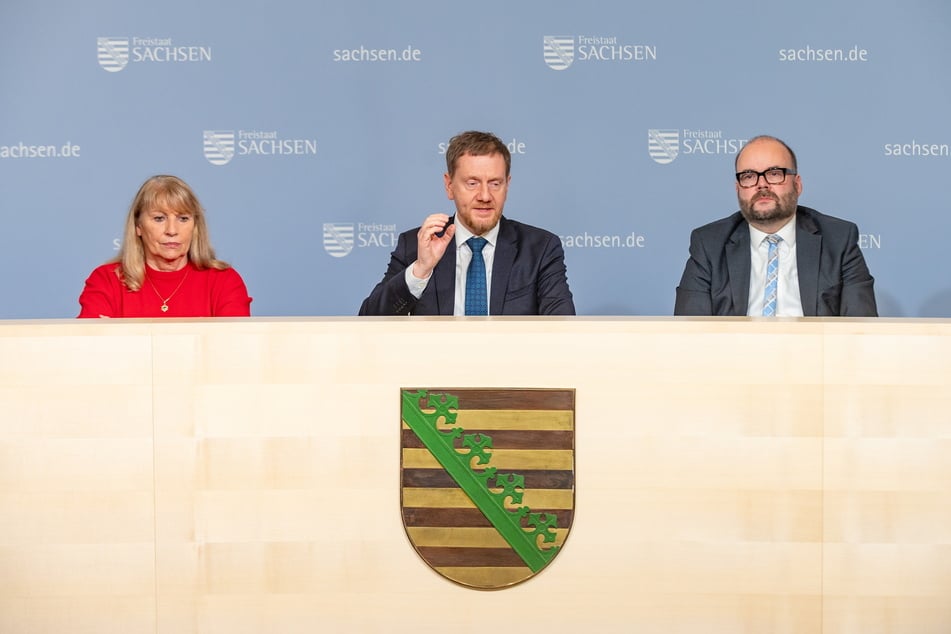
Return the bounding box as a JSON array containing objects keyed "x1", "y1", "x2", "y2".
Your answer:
[{"x1": 0, "y1": 322, "x2": 156, "y2": 634}]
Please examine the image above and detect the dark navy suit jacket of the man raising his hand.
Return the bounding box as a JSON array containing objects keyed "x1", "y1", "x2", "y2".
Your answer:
[{"x1": 360, "y1": 217, "x2": 575, "y2": 315}]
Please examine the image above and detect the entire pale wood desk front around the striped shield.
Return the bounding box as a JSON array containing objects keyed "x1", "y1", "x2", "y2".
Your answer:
[{"x1": 0, "y1": 318, "x2": 951, "y2": 634}]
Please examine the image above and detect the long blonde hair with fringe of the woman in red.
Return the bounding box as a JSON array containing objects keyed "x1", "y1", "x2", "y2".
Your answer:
[{"x1": 114, "y1": 174, "x2": 231, "y2": 291}]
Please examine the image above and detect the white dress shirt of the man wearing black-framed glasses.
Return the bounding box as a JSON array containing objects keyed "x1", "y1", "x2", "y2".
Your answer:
[{"x1": 746, "y1": 215, "x2": 802, "y2": 317}]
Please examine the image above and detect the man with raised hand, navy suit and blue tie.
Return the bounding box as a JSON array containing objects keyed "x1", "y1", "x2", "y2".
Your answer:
[{"x1": 360, "y1": 132, "x2": 575, "y2": 315}]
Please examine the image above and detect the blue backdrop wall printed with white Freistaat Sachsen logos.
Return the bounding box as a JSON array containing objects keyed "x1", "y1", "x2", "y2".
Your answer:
[{"x1": 0, "y1": 0, "x2": 951, "y2": 318}]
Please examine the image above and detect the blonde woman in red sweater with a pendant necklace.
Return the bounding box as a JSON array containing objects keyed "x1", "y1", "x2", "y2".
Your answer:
[{"x1": 79, "y1": 175, "x2": 251, "y2": 317}]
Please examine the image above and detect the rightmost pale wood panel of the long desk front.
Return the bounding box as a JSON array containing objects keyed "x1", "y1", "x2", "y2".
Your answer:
[{"x1": 823, "y1": 321, "x2": 951, "y2": 634}]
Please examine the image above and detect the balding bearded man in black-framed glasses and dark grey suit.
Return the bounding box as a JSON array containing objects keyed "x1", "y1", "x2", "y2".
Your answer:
[{"x1": 674, "y1": 136, "x2": 878, "y2": 317}]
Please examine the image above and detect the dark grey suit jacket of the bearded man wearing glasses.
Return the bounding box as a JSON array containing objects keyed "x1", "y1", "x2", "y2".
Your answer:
[{"x1": 674, "y1": 206, "x2": 878, "y2": 317}]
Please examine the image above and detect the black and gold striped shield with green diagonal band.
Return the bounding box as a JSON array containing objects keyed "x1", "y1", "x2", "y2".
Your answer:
[{"x1": 400, "y1": 388, "x2": 575, "y2": 589}]
